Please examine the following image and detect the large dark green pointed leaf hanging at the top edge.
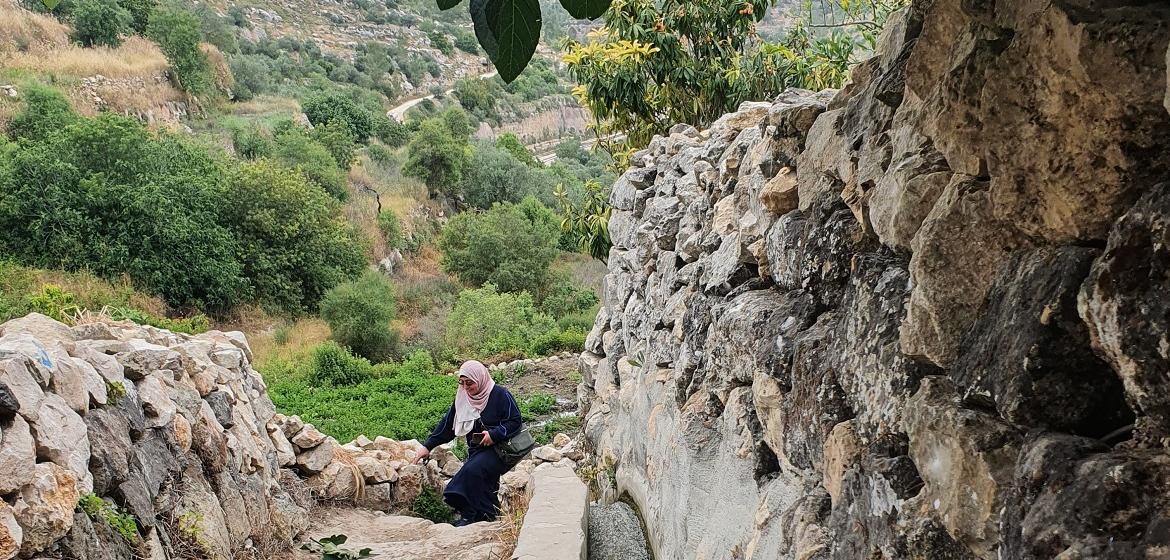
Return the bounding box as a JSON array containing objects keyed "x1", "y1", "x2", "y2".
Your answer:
[{"x1": 470, "y1": 0, "x2": 541, "y2": 83}]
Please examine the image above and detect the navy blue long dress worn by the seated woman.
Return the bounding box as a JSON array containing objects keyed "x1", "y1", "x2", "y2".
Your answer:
[{"x1": 424, "y1": 385, "x2": 522, "y2": 521}]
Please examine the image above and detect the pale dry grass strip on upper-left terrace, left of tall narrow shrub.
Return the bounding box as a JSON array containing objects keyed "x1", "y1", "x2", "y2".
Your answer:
[{"x1": 0, "y1": 34, "x2": 166, "y2": 78}]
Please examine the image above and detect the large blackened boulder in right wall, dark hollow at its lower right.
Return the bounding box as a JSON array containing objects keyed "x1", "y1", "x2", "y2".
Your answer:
[{"x1": 950, "y1": 247, "x2": 1134, "y2": 437}]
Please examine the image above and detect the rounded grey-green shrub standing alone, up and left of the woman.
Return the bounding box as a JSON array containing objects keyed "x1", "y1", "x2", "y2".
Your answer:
[{"x1": 321, "y1": 270, "x2": 398, "y2": 361}]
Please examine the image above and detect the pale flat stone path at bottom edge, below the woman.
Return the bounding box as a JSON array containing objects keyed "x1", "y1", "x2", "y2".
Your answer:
[{"x1": 283, "y1": 507, "x2": 511, "y2": 560}]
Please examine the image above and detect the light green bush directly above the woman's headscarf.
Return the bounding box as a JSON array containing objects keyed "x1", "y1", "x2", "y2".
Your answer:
[{"x1": 447, "y1": 284, "x2": 553, "y2": 357}]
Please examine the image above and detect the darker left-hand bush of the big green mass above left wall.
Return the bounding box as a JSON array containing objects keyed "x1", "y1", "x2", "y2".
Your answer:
[{"x1": 0, "y1": 113, "x2": 249, "y2": 309}]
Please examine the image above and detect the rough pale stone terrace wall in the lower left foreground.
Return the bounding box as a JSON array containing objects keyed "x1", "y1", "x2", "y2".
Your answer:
[{"x1": 0, "y1": 313, "x2": 308, "y2": 559}]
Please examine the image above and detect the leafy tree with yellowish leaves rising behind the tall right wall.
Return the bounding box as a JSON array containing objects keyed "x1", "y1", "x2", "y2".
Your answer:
[{"x1": 564, "y1": 0, "x2": 907, "y2": 157}]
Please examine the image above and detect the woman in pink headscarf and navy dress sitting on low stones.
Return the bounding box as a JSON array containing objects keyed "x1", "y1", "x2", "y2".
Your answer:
[{"x1": 414, "y1": 360, "x2": 522, "y2": 527}]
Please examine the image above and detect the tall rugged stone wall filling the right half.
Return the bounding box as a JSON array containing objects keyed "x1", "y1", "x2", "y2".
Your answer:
[{"x1": 579, "y1": 0, "x2": 1170, "y2": 560}]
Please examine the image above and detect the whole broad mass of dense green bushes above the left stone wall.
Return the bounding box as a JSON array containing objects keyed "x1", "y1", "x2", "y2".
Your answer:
[{"x1": 0, "y1": 96, "x2": 365, "y2": 312}]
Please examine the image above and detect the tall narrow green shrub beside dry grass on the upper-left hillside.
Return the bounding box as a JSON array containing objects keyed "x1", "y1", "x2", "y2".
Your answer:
[{"x1": 146, "y1": 4, "x2": 215, "y2": 96}]
